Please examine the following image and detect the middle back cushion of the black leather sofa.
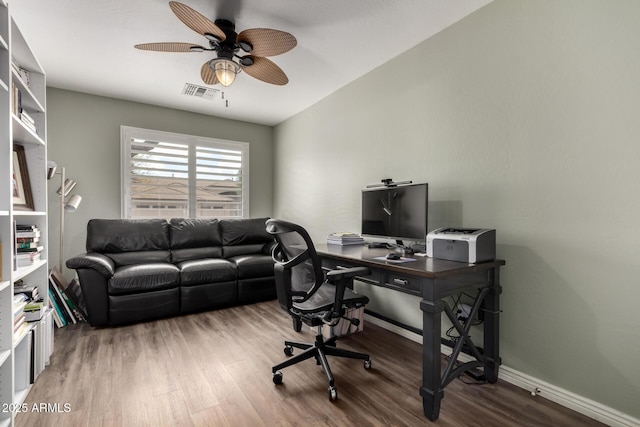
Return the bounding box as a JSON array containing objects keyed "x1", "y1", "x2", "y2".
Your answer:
[{"x1": 169, "y1": 218, "x2": 222, "y2": 263}]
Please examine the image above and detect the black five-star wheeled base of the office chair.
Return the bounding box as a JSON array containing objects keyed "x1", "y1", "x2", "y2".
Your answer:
[{"x1": 271, "y1": 331, "x2": 371, "y2": 400}]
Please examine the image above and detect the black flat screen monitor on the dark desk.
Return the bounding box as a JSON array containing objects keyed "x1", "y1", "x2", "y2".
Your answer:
[{"x1": 362, "y1": 183, "x2": 429, "y2": 244}]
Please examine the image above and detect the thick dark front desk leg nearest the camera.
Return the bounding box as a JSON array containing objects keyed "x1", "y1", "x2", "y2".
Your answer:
[{"x1": 420, "y1": 300, "x2": 444, "y2": 421}]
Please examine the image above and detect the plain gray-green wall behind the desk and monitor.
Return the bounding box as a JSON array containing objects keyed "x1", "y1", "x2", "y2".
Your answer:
[{"x1": 274, "y1": 0, "x2": 640, "y2": 417}]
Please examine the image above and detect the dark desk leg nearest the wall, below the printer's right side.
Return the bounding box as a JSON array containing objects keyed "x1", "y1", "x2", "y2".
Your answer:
[{"x1": 484, "y1": 268, "x2": 502, "y2": 384}]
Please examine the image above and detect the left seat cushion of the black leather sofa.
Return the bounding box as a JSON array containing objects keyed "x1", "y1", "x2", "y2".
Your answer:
[{"x1": 108, "y1": 262, "x2": 180, "y2": 295}]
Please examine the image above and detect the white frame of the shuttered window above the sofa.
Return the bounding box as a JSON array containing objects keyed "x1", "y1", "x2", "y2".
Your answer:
[{"x1": 120, "y1": 126, "x2": 249, "y2": 219}]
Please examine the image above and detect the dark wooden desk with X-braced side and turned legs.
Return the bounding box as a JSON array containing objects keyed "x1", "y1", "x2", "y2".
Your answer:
[{"x1": 316, "y1": 245, "x2": 505, "y2": 420}]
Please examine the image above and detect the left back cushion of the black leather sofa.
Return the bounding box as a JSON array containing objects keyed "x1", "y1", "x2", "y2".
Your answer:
[{"x1": 87, "y1": 219, "x2": 171, "y2": 266}]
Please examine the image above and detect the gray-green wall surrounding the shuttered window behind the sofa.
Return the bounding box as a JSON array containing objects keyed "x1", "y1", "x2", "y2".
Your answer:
[{"x1": 47, "y1": 88, "x2": 273, "y2": 277}]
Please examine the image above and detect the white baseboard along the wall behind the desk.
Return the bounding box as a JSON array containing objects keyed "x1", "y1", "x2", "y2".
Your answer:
[{"x1": 365, "y1": 314, "x2": 640, "y2": 427}]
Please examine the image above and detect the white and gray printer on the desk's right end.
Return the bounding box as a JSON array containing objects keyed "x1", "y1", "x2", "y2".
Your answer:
[{"x1": 427, "y1": 228, "x2": 496, "y2": 264}]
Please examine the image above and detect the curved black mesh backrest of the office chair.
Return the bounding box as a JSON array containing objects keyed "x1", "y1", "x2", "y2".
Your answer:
[{"x1": 266, "y1": 219, "x2": 324, "y2": 311}]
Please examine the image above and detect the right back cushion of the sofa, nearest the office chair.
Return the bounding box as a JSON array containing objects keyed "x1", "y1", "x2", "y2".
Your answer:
[{"x1": 220, "y1": 218, "x2": 273, "y2": 258}]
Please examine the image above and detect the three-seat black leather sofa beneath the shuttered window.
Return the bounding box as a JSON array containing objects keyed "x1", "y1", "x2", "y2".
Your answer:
[{"x1": 66, "y1": 218, "x2": 276, "y2": 326}]
